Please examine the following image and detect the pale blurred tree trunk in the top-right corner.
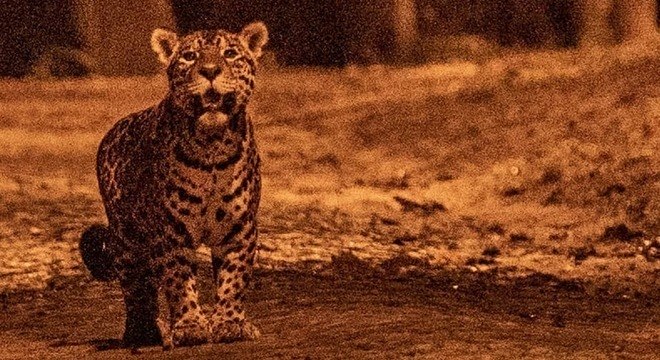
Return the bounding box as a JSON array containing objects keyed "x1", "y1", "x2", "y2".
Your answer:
[{"x1": 615, "y1": 0, "x2": 657, "y2": 42}]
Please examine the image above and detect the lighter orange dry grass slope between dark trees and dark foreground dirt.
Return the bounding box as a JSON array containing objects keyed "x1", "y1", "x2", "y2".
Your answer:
[{"x1": 0, "y1": 45, "x2": 660, "y2": 287}]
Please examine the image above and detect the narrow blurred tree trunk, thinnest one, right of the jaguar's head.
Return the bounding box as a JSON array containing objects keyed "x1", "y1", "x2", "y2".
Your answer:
[{"x1": 392, "y1": 0, "x2": 417, "y2": 61}]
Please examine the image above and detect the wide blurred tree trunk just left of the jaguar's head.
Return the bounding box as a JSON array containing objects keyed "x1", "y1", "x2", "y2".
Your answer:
[{"x1": 73, "y1": 0, "x2": 174, "y2": 75}]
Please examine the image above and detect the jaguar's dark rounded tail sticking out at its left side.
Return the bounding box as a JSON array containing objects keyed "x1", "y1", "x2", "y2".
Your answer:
[{"x1": 79, "y1": 224, "x2": 117, "y2": 281}]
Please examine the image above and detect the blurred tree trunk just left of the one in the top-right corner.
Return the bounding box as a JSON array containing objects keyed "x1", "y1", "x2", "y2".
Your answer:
[{"x1": 579, "y1": 0, "x2": 614, "y2": 46}]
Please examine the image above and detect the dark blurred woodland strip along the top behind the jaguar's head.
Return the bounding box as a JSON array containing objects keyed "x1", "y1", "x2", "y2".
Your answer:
[{"x1": 0, "y1": 0, "x2": 657, "y2": 76}]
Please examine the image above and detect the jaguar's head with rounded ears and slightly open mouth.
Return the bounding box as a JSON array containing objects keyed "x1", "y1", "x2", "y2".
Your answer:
[{"x1": 151, "y1": 22, "x2": 268, "y2": 127}]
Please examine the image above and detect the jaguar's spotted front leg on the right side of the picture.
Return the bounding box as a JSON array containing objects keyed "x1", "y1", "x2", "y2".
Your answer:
[{"x1": 210, "y1": 222, "x2": 260, "y2": 342}]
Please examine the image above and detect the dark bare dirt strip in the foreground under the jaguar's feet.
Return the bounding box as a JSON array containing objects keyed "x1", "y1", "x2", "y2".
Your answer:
[{"x1": 0, "y1": 263, "x2": 660, "y2": 359}]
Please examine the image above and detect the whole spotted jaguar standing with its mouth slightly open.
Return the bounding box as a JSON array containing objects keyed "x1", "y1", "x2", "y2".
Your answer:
[{"x1": 80, "y1": 23, "x2": 268, "y2": 348}]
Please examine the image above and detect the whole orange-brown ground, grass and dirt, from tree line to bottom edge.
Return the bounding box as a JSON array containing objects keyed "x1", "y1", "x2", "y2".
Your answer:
[{"x1": 0, "y1": 46, "x2": 660, "y2": 359}]
